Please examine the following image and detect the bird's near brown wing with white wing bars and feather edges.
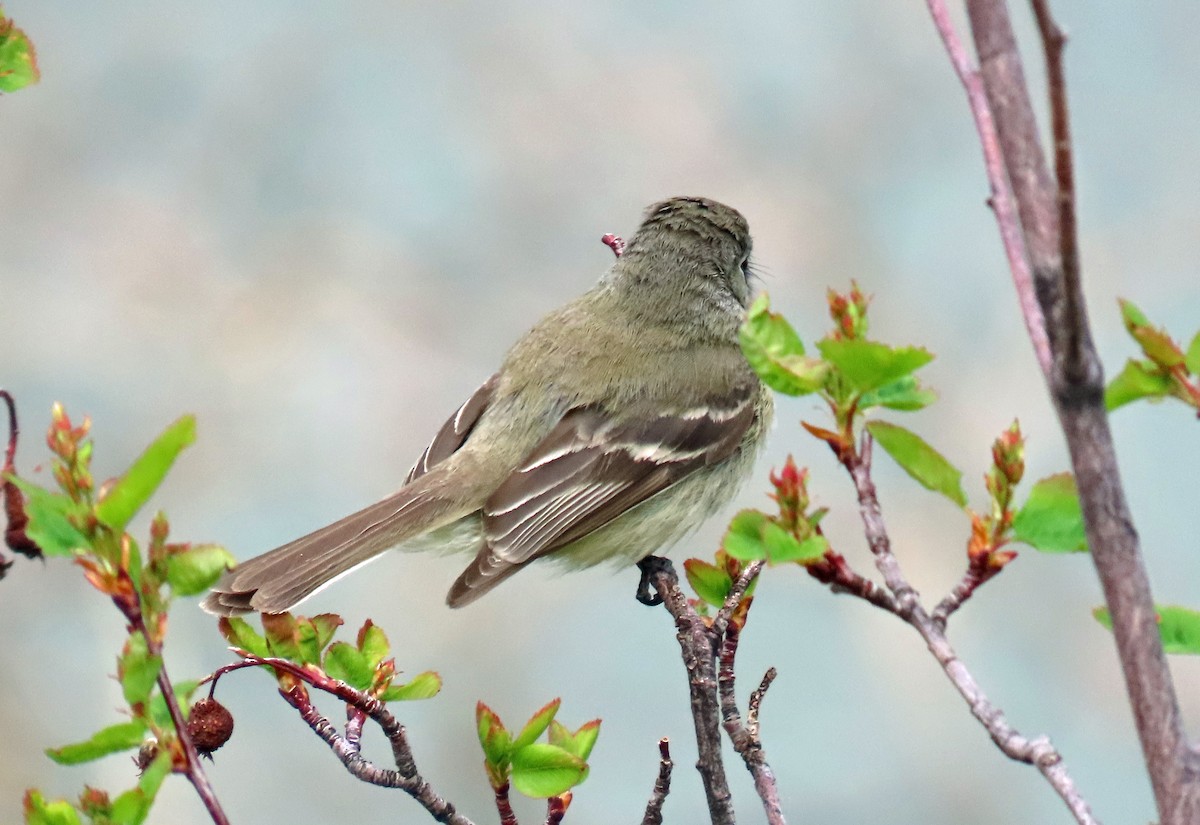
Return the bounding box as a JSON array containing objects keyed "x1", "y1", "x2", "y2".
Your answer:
[{"x1": 448, "y1": 393, "x2": 755, "y2": 606}]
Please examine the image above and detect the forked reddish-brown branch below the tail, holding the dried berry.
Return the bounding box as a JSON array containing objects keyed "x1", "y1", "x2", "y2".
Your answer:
[{"x1": 200, "y1": 656, "x2": 474, "y2": 825}]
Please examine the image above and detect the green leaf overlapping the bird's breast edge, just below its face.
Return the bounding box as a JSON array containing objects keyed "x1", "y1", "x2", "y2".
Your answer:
[{"x1": 738, "y1": 295, "x2": 829, "y2": 396}]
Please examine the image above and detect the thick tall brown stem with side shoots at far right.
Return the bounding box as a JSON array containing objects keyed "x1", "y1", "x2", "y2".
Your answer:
[{"x1": 928, "y1": 0, "x2": 1200, "y2": 825}]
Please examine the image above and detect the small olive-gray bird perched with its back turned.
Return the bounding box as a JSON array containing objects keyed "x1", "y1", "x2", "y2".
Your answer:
[{"x1": 203, "y1": 198, "x2": 773, "y2": 615}]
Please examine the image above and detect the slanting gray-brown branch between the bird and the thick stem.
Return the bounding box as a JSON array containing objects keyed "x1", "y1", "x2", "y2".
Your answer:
[{"x1": 842, "y1": 435, "x2": 1097, "y2": 825}]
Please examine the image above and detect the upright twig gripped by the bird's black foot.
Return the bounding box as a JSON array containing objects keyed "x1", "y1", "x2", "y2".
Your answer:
[{"x1": 637, "y1": 556, "x2": 734, "y2": 825}]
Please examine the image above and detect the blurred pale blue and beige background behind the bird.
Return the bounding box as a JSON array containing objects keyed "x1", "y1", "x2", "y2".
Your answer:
[{"x1": 0, "y1": 0, "x2": 1200, "y2": 825}]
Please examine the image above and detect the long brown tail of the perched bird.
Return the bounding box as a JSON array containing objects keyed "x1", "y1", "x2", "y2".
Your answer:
[{"x1": 200, "y1": 474, "x2": 473, "y2": 616}]
